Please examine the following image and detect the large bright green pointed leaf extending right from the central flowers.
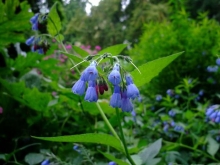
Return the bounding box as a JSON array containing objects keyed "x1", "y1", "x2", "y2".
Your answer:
[{"x1": 131, "y1": 52, "x2": 183, "y2": 86}]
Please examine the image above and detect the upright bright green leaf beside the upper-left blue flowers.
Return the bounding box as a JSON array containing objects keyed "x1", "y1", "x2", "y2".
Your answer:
[{"x1": 47, "y1": 2, "x2": 62, "y2": 36}]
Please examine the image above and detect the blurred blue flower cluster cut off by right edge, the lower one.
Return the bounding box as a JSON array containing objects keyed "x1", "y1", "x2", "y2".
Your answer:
[{"x1": 206, "y1": 104, "x2": 220, "y2": 123}]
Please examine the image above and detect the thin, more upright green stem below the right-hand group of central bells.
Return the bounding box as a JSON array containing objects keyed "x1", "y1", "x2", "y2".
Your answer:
[{"x1": 115, "y1": 108, "x2": 135, "y2": 165}]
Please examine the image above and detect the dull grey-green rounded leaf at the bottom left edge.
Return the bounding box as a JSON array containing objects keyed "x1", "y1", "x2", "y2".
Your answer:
[{"x1": 24, "y1": 153, "x2": 44, "y2": 165}]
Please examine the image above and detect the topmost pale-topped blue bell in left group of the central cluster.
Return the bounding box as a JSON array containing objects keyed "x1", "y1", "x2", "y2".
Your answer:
[{"x1": 83, "y1": 61, "x2": 98, "y2": 81}]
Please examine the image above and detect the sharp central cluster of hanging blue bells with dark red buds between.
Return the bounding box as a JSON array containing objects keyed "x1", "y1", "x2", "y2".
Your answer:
[{"x1": 72, "y1": 61, "x2": 140, "y2": 112}]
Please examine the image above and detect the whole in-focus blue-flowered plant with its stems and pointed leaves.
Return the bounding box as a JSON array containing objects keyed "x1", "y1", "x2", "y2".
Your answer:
[{"x1": 26, "y1": 3, "x2": 182, "y2": 165}]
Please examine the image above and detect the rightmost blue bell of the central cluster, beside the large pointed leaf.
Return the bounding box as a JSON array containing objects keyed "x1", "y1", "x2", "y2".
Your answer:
[{"x1": 125, "y1": 75, "x2": 140, "y2": 99}]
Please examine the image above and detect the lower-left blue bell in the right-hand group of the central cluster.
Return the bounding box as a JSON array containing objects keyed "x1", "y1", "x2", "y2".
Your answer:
[{"x1": 110, "y1": 85, "x2": 121, "y2": 108}]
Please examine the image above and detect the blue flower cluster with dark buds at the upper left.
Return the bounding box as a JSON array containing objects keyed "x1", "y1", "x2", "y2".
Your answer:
[{"x1": 25, "y1": 13, "x2": 48, "y2": 54}]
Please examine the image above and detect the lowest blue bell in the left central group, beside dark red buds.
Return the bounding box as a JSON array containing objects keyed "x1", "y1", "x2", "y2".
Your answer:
[{"x1": 84, "y1": 81, "x2": 98, "y2": 102}]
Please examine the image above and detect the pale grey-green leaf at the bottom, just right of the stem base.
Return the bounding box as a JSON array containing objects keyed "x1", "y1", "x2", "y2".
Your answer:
[{"x1": 138, "y1": 139, "x2": 162, "y2": 163}]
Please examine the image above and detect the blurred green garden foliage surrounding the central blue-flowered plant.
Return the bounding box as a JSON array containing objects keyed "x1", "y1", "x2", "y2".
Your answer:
[{"x1": 0, "y1": 0, "x2": 220, "y2": 165}]
